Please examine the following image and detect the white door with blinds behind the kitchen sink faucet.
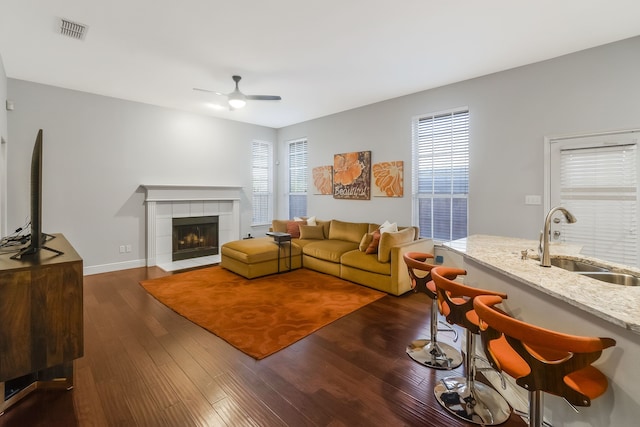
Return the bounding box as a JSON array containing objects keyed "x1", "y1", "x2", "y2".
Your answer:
[{"x1": 545, "y1": 130, "x2": 640, "y2": 266}]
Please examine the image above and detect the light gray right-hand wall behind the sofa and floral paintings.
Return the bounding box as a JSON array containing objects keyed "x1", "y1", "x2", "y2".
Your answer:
[{"x1": 278, "y1": 37, "x2": 640, "y2": 238}]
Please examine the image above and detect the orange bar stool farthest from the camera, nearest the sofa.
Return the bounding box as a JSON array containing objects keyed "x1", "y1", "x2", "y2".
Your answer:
[{"x1": 403, "y1": 252, "x2": 462, "y2": 369}]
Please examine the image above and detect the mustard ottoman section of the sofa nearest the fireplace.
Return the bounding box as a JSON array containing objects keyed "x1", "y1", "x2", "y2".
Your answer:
[{"x1": 220, "y1": 237, "x2": 302, "y2": 279}]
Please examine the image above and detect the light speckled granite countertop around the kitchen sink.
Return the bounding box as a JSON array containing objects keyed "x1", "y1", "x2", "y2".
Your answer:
[{"x1": 444, "y1": 235, "x2": 640, "y2": 334}]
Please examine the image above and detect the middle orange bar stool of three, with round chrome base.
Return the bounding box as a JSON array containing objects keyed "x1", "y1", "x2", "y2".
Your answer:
[{"x1": 431, "y1": 267, "x2": 511, "y2": 426}]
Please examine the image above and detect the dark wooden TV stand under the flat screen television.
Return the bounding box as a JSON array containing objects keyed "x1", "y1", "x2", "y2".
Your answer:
[{"x1": 0, "y1": 234, "x2": 84, "y2": 414}]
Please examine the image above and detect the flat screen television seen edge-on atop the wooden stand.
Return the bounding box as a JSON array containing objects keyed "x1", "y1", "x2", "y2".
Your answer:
[{"x1": 11, "y1": 129, "x2": 62, "y2": 259}]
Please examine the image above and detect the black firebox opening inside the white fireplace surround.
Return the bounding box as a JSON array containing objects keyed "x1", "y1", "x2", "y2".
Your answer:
[{"x1": 171, "y1": 216, "x2": 218, "y2": 261}]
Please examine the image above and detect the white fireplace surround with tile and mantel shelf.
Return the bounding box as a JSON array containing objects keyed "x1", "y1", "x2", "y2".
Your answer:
[{"x1": 142, "y1": 185, "x2": 242, "y2": 271}]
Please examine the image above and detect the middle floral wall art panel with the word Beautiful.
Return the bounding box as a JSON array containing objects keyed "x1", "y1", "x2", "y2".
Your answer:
[{"x1": 333, "y1": 151, "x2": 371, "y2": 200}]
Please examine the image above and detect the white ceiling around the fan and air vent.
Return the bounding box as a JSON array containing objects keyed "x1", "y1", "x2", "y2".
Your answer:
[{"x1": 0, "y1": 0, "x2": 640, "y2": 128}]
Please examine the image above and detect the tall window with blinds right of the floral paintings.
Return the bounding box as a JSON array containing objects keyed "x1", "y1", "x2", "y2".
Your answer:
[{"x1": 412, "y1": 108, "x2": 469, "y2": 241}]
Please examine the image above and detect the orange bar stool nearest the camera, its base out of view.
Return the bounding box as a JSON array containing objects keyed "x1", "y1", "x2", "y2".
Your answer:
[{"x1": 473, "y1": 295, "x2": 616, "y2": 427}]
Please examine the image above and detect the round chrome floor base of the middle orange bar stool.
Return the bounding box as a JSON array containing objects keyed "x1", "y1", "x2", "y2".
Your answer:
[{"x1": 434, "y1": 377, "x2": 511, "y2": 426}]
